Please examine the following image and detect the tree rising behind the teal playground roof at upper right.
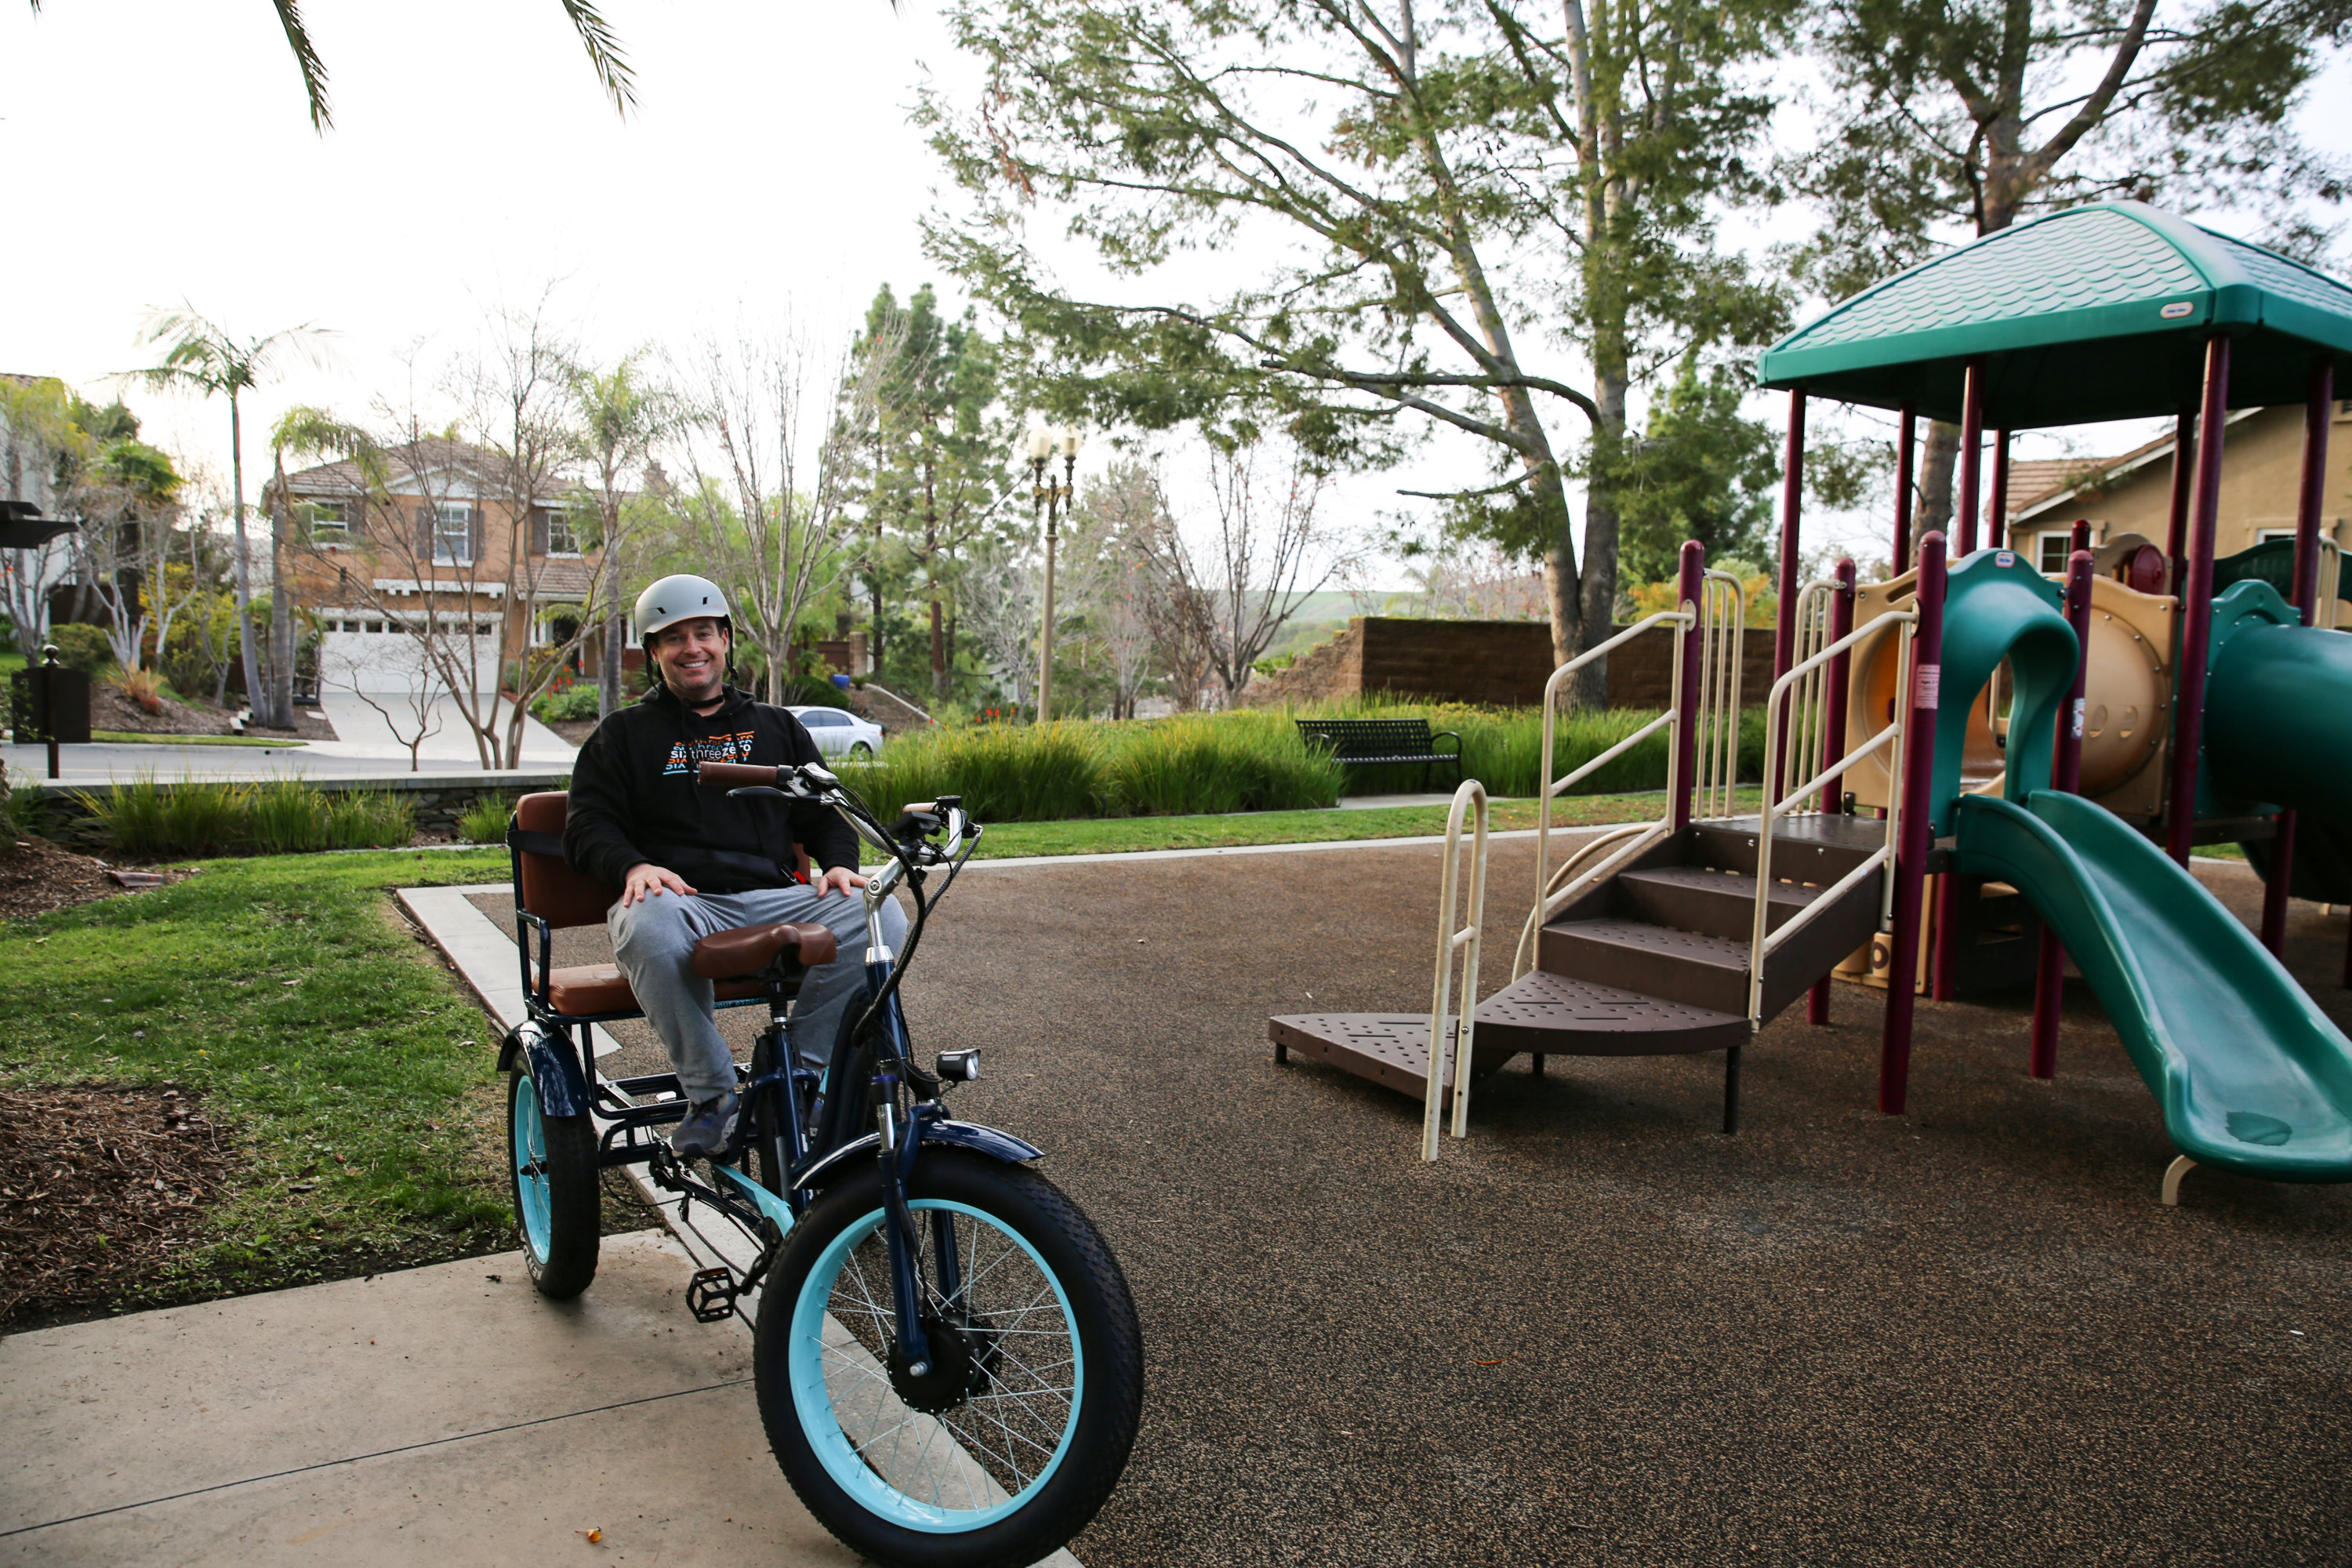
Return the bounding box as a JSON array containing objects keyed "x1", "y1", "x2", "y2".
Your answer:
[{"x1": 1790, "y1": 0, "x2": 2352, "y2": 527}]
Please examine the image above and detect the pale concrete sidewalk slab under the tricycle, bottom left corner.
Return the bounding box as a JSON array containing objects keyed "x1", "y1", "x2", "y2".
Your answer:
[{"x1": 0, "y1": 1232, "x2": 858, "y2": 1568}]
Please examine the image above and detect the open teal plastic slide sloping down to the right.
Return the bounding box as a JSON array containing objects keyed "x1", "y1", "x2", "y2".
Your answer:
[{"x1": 1955, "y1": 789, "x2": 2352, "y2": 1182}]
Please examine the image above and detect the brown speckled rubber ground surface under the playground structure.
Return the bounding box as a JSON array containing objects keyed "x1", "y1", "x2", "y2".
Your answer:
[{"x1": 480, "y1": 841, "x2": 2352, "y2": 1568}]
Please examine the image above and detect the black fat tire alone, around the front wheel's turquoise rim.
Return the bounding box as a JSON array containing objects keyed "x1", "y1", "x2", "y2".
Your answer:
[{"x1": 753, "y1": 1149, "x2": 1143, "y2": 1568}]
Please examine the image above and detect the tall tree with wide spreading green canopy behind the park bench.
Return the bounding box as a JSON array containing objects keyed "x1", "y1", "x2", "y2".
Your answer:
[{"x1": 920, "y1": 0, "x2": 1795, "y2": 701}]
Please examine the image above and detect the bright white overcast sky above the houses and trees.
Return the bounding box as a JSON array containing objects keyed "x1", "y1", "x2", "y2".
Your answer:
[{"x1": 0, "y1": 0, "x2": 2352, "y2": 587}]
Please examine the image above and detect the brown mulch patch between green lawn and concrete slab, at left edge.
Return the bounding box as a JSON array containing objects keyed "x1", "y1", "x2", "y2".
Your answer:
[{"x1": 0, "y1": 1086, "x2": 235, "y2": 1328}]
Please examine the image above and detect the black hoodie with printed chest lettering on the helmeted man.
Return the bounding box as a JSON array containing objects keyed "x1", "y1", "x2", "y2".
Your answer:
[{"x1": 564, "y1": 684, "x2": 858, "y2": 893}]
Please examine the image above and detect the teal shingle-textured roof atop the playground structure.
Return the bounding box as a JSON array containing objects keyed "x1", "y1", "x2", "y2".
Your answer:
[{"x1": 1757, "y1": 202, "x2": 2352, "y2": 430}]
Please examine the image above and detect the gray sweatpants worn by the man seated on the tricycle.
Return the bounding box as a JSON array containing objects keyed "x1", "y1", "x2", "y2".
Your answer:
[{"x1": 604, "y1": 886, "x2": 906, "y2": 1105}]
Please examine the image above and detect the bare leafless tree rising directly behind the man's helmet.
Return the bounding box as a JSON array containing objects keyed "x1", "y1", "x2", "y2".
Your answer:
[{"x1": 675, "y1": 332, "x2": 894, "y2": 703}]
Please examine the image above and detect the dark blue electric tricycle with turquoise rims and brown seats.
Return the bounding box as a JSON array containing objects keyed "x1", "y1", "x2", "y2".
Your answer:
[{"x1": 501, "y1": 762, "x2": 1143, "y2": 1568}]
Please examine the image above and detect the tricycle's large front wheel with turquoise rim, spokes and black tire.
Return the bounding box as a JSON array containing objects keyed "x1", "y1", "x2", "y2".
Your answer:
[{"x1": 753, "y1": 1149, "x2": 1143, "y2": 1568}]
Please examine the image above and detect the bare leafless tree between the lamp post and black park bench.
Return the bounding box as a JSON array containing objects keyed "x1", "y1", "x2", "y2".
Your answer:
[{"x1": 1138, "y1": 445, "x2": 1338, "y2": 699}]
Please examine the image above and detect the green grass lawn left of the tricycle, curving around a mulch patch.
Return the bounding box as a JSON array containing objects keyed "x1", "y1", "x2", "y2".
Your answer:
[{"x1": 0, "y1": 851, "x2": 510, "y2": 1305}]
